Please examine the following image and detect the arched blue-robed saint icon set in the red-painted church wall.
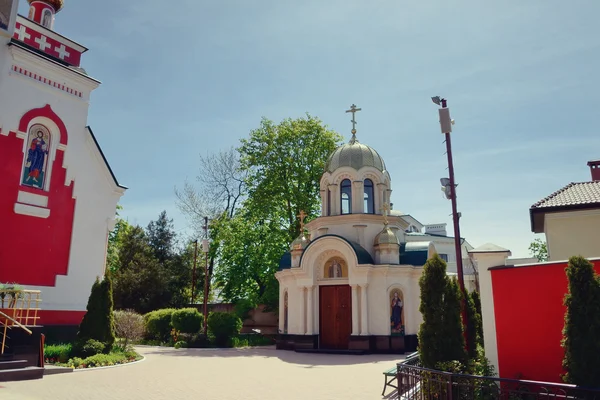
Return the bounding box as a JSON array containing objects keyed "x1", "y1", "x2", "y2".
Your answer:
[{"x1": 21, "y1": 124, "x2": 50, "y2": 189}]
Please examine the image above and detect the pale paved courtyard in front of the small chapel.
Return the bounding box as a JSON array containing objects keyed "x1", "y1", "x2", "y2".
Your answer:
[{"x1": 0, "y1": 347, "x2": 400, "y2": 400}]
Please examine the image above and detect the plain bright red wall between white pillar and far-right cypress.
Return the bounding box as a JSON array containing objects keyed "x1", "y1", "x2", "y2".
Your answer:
[{"x1": 491, "y1": 260, "x2": 600, "y2": 382}]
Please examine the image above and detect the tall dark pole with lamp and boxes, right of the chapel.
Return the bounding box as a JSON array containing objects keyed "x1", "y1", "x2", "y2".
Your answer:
[{"x1": 431, "y1": 96, "x2": 469, "y2": 349}]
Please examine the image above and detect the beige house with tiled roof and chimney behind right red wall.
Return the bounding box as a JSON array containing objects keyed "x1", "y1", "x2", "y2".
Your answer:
[{"x1": 529, "y1": 160, "x2": 600, "y2": 261}]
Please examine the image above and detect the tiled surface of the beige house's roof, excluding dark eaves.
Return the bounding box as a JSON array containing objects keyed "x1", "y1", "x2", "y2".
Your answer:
[{"x1": 531, "y1": 181, "x2": 600, "y2": 210}]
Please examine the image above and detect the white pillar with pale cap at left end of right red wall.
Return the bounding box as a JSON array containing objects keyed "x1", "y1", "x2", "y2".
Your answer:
[{"x1": 469, "y1": 245, "x2": 511, "y2": 377}]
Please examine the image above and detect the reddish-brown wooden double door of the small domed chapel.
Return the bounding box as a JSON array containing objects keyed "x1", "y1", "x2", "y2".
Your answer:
[{"x1": 319, "y1": 285, "x2": 352, "y2": 350}]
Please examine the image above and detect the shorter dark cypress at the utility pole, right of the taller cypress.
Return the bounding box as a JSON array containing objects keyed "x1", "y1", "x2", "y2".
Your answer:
[{"x1": 440, "y1": 278, "x2": 467, "y2": 362}]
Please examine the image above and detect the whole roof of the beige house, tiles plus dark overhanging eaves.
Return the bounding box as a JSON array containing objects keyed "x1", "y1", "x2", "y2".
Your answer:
[{"x1": 529, "y1": 181, "x2": 600, "y2": 233}]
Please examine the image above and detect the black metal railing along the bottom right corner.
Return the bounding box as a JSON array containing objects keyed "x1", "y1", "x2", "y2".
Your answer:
[{"x1": 397, "y1": 353, "x2": 600, "y2": 400}]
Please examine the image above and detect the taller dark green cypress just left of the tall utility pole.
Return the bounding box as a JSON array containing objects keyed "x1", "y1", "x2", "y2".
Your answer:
[{"x1": 418, "y1": 254, "x2": 448, "y2": 368}]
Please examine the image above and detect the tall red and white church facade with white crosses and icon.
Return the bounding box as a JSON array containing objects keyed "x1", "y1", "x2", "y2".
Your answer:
[{"x1": 0, "y1": 0, "x2": 126, "y2": 325}]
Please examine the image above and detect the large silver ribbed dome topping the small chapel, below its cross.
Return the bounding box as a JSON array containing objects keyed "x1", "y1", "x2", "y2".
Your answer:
[{"x1": 325, "y1": 137, "x2": 385, "y2": 173}]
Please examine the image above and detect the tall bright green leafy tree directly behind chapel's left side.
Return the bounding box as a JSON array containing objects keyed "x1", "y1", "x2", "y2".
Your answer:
[{"x1": 239, "y1": 114, "x2": 342, "y2": 241}]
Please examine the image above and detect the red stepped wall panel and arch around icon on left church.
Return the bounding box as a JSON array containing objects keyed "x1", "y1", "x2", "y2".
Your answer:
[{"x1": 0, "y1": 107, "x2": 75, "y2": 286}]
